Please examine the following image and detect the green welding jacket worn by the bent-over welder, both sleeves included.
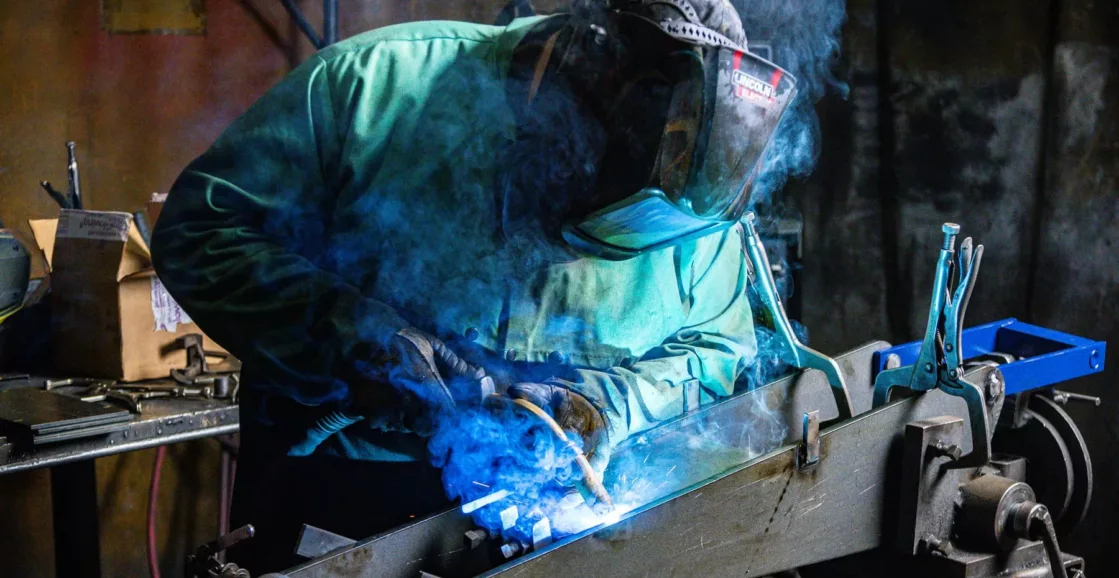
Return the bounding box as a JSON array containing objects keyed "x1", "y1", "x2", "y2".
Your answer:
[{"x1": 152, "y1": 18, "x2": 756, "y2": 461}]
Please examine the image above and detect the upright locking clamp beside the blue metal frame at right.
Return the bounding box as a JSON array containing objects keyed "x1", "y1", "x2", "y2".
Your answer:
[{"x1": 874, "y1": 222, "x2": 990, "y2": 467}]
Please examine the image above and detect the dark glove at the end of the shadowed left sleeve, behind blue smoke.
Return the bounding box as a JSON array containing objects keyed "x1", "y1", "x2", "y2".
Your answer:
[{"x1": 350, "y1": 328, "x2": 485, "y2": 436}]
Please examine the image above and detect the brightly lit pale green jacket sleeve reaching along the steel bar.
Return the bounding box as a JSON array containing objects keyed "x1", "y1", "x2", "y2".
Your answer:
[{"x1": 552, "y1": 226, "x2": 758, "y2": 445}]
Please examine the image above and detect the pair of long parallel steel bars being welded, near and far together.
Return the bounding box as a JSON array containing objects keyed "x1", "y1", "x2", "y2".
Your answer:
[{"x1": 288, "y1": 343, "x2": 1011, "y2": 578}]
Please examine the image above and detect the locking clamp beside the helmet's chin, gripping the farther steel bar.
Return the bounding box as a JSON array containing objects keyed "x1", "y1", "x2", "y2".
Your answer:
[{"x1": 742, "y1": 212, "x2": 854, "y2": 420}]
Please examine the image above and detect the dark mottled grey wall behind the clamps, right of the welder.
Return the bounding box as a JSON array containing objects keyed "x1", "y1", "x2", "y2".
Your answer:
[{"x1": 787, "y1": 0, "x2": 1119, "y2": 576}]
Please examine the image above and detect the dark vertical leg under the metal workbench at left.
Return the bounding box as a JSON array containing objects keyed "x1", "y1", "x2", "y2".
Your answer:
[{"x1": 50, "y1": 459, "x2": 101, "y2": 578}]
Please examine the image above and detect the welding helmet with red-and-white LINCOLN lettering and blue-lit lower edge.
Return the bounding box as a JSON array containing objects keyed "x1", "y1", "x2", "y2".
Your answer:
[{"x1": 519, "y1": 0, "x2": 797, "y2": 260}]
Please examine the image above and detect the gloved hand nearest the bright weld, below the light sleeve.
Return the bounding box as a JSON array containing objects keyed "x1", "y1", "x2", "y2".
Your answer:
[{"x1": 508, "y1": 383, "x2": 610, "y2": 477}]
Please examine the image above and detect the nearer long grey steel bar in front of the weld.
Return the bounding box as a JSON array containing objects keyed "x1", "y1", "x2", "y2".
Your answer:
[{"x1": 485, "y1": 382, "x2": 970, "y2": 577}]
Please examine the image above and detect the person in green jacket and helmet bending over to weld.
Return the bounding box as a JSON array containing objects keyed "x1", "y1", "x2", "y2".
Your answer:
[{"x1": 152, "y1": 0, "x2": 794, "y2": 572}]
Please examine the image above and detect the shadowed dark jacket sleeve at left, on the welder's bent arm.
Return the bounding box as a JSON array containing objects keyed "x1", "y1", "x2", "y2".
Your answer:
[{"x1": 152, "y1": 56, "x2": 405, "y2": 404}]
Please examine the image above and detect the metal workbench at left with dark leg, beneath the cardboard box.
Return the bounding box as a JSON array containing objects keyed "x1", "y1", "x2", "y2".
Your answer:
[{"x1": 0, "y1": 378, "x2": 239, "y2": 577}]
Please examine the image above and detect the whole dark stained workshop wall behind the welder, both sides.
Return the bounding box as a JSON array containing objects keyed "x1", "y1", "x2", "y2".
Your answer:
[{"x1": 0, "y1": 0, "x2": 1119, "y2": 577}]
